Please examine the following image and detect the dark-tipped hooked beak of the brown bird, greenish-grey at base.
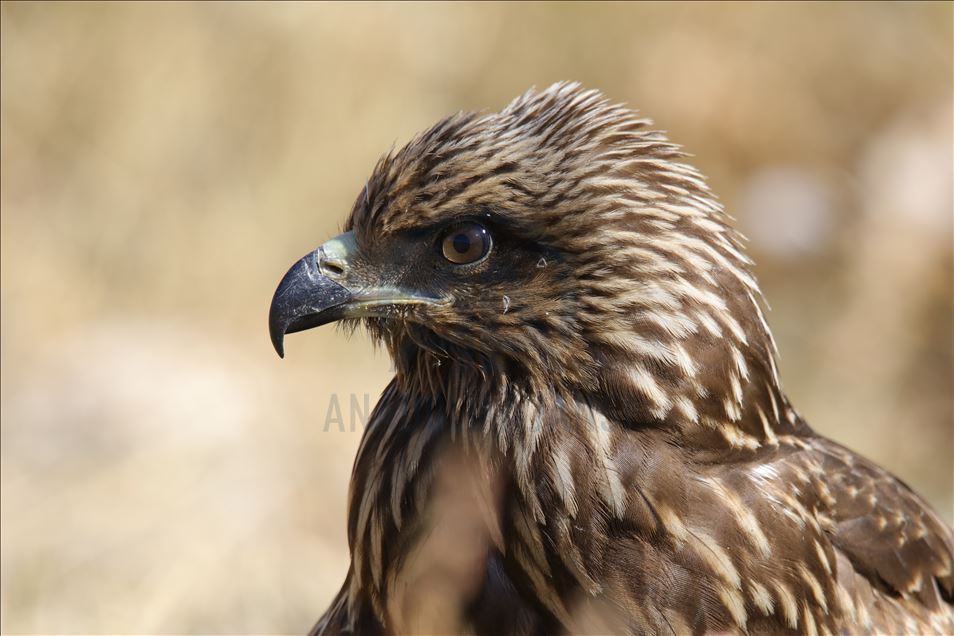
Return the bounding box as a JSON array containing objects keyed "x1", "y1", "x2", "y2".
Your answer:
[{"x1": 268, "y1": 232, "x2": 438, "y2": 358}]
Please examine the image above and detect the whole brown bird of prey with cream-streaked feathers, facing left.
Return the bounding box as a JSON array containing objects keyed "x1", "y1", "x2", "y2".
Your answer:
[{"x1": 269, "y1": 83, "x2": 954, "y2": 634}]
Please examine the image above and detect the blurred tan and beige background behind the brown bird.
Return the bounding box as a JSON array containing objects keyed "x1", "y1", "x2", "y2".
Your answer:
[{"x1": 0, "y1": 2, "x2": 954, "y2": 634}]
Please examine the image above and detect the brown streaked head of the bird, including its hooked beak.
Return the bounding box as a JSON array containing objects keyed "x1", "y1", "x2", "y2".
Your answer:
[{"x1": 270, "y1": 83, "x2": 777, "y2": 446}]
